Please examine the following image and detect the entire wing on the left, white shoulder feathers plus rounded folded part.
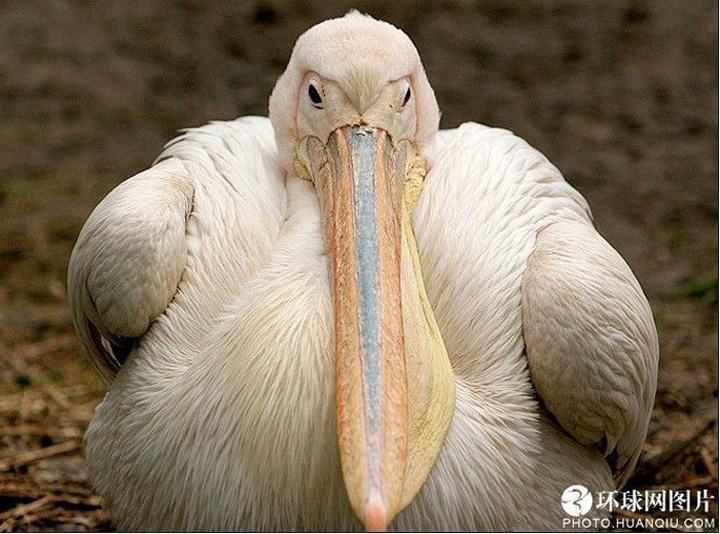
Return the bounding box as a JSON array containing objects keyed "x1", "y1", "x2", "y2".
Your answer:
[{"x1": 68, "y1": 117, "x2": 285, "y2": 381}]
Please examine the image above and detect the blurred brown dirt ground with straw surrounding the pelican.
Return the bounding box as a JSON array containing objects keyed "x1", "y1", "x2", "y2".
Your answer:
[{"x1": 0, "y1": 0, "x2": 718, "y2": 531}]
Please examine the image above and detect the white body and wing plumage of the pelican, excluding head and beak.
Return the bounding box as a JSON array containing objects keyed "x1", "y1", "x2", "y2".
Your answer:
[{"x1": 69, "y1": 13, "x2": 658, "y2": 530}]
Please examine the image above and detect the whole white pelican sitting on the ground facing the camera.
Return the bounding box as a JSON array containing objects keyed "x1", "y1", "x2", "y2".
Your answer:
[{"x1": 68, "y1": 12, "x2": 658, "y2": 531}]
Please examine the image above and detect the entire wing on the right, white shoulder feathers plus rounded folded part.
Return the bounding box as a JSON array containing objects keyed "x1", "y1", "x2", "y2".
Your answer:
[{"x1": 414, "y1": 123, "x2": 658, "y2": 492}]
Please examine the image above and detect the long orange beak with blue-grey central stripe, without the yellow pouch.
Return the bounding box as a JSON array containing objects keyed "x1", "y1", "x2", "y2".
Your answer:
[{"x1": 298, "y1": 126, "x2": 408, "y2": 531}]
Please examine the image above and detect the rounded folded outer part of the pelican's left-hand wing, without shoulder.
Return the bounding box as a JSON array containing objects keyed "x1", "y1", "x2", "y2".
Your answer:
[{"x1": 68, "y1": 158, "x2": 193, "y2": 386}]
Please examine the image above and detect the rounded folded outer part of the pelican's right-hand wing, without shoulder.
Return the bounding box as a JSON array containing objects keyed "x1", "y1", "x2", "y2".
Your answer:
[{"x1": 522, "y1": 221, "x2": 658, "y2": 487}]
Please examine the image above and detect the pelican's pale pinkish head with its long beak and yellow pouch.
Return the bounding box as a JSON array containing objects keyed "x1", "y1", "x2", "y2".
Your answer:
[{"x1": 270, "y1": 12, "x2": 454, "y2": 530}]
